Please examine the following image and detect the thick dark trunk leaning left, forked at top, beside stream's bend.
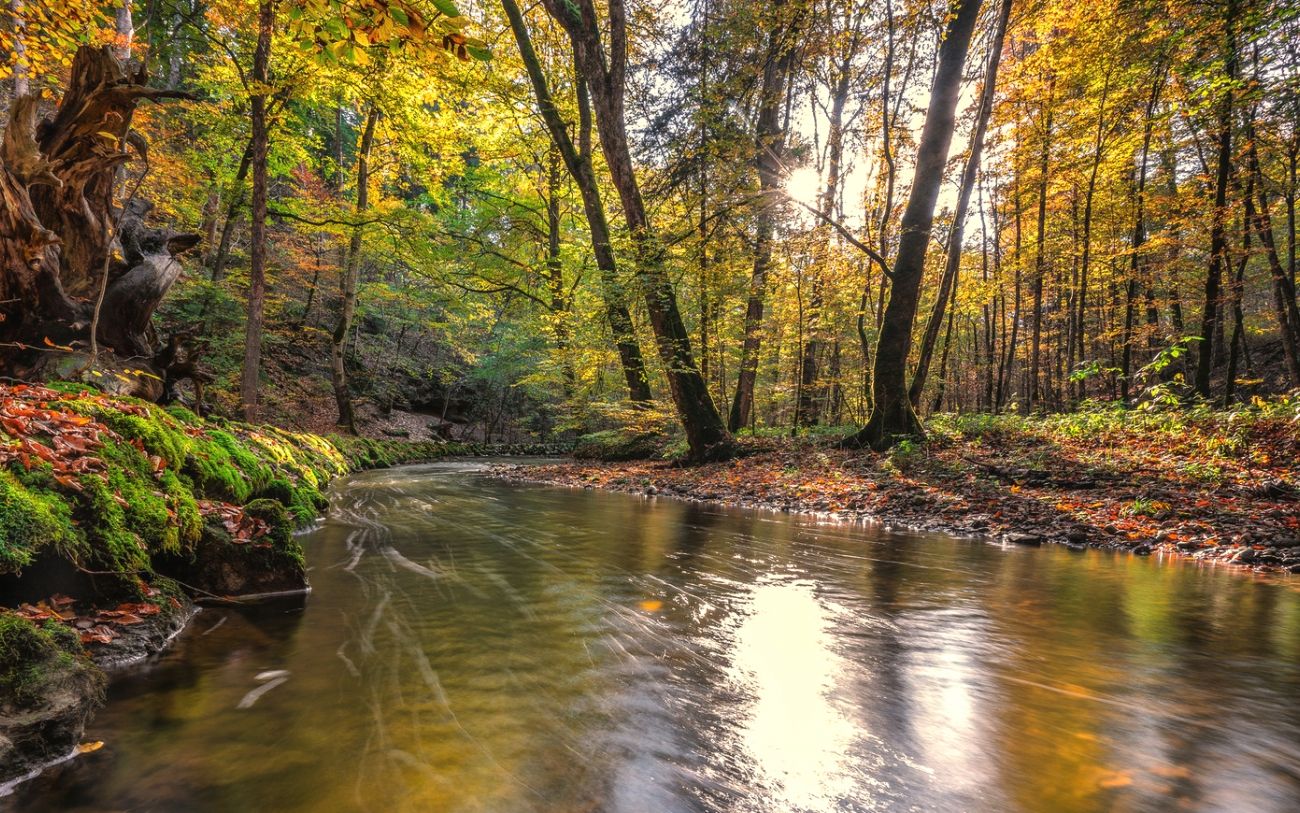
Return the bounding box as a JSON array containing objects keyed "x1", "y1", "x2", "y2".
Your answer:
[{"x1": 545, "y1": 0, "x2": 733, "y2": 460}]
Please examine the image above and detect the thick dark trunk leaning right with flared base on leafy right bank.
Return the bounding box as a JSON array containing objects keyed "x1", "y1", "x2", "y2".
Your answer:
[{"x1": 845, "y1": 0, "x2": 980, "y2": 450}]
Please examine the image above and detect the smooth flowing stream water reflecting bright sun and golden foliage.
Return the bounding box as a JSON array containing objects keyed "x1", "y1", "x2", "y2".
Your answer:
[{"x1": 0, "y1": 463, "x2": 1300, "y2": 813}]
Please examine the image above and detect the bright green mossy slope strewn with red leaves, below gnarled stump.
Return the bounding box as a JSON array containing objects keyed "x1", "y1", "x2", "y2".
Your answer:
[{"x1": 0, "y1": 385, "x2": 463, "y2": 585}]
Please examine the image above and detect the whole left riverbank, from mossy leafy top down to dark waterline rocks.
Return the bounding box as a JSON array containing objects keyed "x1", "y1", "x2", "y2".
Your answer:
[{"x1": 0, "y1": 384, "x2": 548, "y2": 783}]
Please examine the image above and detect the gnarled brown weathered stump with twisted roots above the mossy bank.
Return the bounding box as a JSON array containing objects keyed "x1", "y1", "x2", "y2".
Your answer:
[{"x1": 0, "y1": 47, "x2": 200, "y2": 399}]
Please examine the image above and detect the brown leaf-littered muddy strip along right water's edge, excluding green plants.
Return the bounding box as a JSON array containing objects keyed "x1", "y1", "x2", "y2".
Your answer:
[{"x1": 493, "y1": 434, "x2": 1300, "y2": 572}]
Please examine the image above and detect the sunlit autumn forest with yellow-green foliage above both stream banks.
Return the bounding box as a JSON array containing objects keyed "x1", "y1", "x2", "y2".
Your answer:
[{"x1": 0, "y1": 0, "x2": 1300, "y2": 459}]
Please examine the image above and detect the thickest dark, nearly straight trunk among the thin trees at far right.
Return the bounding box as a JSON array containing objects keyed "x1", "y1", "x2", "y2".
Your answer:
[{"x1": 1195, "y1": 0, "x2": 1238, "y2": 398}]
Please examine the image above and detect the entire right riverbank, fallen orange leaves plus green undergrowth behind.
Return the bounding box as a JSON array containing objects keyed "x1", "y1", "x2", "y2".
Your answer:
[{"x1": 495, "y1": 402, "x2": 1300, "y2": 572}]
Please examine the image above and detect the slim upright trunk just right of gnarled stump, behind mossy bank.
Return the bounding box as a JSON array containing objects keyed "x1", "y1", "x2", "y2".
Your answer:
[{"x1": 239, "y1": 0, "x2": 276, "y2": 423}]
